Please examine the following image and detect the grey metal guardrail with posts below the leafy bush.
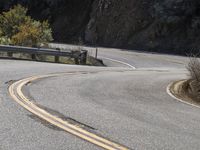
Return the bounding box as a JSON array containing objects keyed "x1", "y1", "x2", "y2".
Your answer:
[{"x1": 0, "y1": 45, "x2": 87, "y2": 64}]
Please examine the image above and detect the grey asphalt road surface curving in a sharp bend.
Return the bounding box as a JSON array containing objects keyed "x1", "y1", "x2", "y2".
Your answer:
[{"x1": 0, "y1": 45, "x2": 200, "y2": 150}]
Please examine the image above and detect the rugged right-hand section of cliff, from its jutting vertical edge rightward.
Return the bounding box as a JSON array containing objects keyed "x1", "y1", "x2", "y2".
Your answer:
[{"x1": 85, "y1": 0, "x2": 200, "y2": 53}]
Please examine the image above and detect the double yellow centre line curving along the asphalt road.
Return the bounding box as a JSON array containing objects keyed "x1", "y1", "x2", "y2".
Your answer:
[{"x1": 9, "y1": 73, "x2": 128, "y2": 150}]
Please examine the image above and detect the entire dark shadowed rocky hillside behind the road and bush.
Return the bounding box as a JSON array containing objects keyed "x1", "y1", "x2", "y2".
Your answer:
[{"x1": 0, "y1": 0, "x2": 200, "y2": 54}]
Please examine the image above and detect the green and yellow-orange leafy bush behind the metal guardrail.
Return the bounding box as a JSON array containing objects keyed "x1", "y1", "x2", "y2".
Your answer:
[{"x1": 0, "y1": 5, "x2": 53, "y2": 46}]
